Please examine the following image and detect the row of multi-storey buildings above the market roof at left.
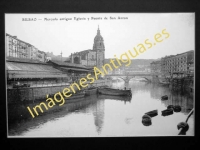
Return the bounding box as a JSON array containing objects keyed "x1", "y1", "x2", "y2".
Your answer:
[{"x1": 6, "y1": 33, "x2": 46, "y2": 62}]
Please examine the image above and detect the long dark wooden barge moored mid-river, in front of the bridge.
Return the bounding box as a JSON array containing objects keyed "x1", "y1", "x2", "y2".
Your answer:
[{"x1": 98, "y1": 88, "x2": 132, "y2": 96}]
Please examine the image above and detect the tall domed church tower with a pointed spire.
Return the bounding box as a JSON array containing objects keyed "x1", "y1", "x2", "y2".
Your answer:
[{"x1": 93, "y1": 26, "x2": 105, "y2": 68}]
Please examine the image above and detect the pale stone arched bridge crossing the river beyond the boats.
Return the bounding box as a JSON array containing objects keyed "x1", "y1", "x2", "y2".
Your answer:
[{"x1": 105, "y1": 73, "x2": 160, "y2": 83}]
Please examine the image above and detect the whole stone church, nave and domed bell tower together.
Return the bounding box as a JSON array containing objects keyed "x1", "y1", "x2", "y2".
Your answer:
[{"x1": 70, "y1": 28, "x2": 105, "y2": 68}]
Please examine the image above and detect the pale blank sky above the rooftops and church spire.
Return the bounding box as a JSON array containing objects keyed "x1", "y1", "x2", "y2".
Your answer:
[{"x1": 5, "y1": 13, "x2": 195, "y2": 59}]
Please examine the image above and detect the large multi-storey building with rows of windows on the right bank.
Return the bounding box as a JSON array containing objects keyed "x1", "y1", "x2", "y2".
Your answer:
[{"x1": 161, "y1": 50, "x2": 194, "y2": 74}]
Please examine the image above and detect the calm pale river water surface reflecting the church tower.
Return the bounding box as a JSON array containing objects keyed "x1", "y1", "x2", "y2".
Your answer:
[{"x1": 9, "y1": 80, "x2": 194, "y2": 137}]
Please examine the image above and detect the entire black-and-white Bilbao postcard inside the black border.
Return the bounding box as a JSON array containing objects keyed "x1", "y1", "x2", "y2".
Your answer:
[{"x1": 5, "y1": 12, "x2": 195, "y2": 138}]
